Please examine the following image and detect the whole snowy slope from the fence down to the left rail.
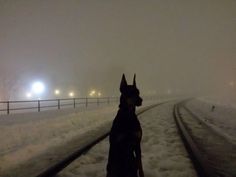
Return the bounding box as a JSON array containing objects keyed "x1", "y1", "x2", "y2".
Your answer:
[{"x1": 0, "y1": 102, "x2": 159, "y2": 177}]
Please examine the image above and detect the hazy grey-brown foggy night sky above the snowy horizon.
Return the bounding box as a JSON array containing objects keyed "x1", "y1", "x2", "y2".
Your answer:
[{"x1": 0, "y1": 0, "x2": 236, "y2": 99}]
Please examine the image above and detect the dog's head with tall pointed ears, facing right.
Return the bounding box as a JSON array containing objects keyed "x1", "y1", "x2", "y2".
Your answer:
[{"x1": 120, "y1": 74, "x2": 143, "y2": 107}]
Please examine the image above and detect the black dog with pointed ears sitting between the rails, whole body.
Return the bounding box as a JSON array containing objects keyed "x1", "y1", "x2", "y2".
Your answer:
[{"x1": 107, "y1": 74, "x2": 144, "y2": 177}]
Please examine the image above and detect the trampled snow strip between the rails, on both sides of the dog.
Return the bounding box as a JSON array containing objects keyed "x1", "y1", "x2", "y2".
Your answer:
[{"x1": 57, "y1": 102, "x2": 197, "y2": 177}]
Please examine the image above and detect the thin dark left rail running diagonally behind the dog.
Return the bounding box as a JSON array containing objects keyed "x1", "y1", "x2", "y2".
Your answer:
[{"x1": 36, "y1": 102, "x2": 166, "y2": 177}]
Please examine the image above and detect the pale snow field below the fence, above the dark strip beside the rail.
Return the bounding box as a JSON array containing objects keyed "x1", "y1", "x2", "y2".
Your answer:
[{"x1": 0, "y1": 105, "x2": 117, "y2": 177}]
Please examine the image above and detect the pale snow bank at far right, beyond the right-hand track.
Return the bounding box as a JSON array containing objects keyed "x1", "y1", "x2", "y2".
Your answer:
[{"x1": 186, "y1": 98, "x2": 236, "y2": 143}]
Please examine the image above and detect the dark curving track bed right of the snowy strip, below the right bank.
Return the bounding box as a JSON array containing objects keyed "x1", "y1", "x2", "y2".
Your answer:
[{"x1": 173, "y1": 102, "x2": 236, "y2": 177}]
